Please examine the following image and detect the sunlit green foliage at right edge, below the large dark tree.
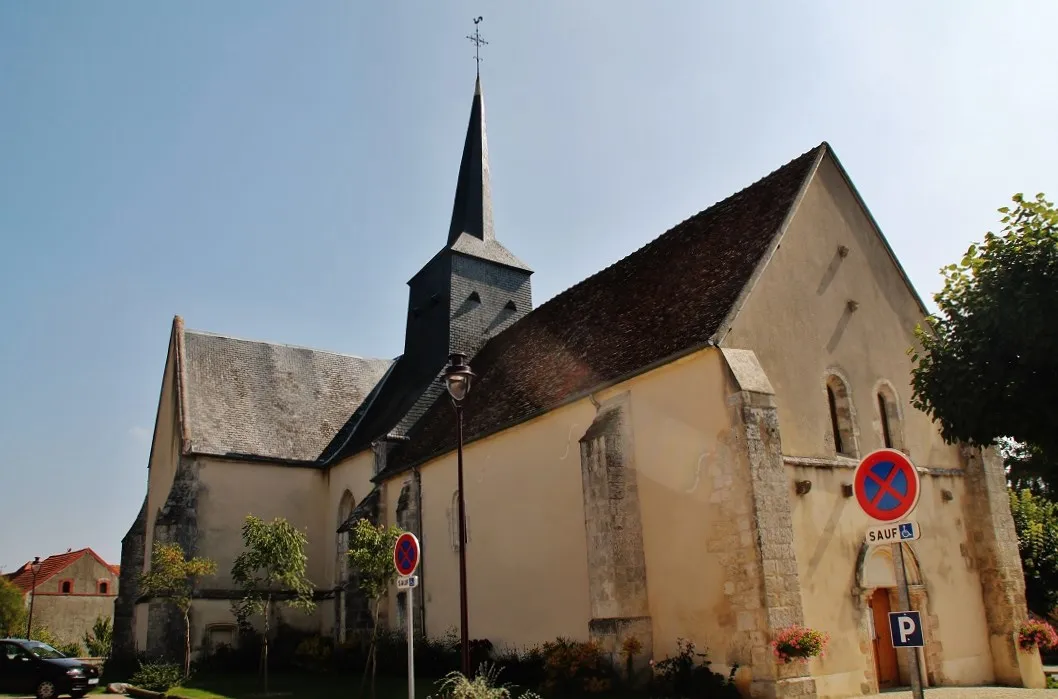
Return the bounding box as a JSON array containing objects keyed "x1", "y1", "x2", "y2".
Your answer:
[{"x1": 1010, "y1": 490, "x2": 1058, "y2": 617}]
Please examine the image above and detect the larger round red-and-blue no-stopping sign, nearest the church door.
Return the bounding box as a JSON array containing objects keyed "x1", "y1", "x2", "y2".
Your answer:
[{"x1": 854, "y1": 449, "x2": 922, "y2": 521}]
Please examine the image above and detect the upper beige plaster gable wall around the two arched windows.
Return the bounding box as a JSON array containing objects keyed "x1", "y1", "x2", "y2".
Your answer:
[{"x1": 722, "y1": 157, "x2": 962, "y2": 468}]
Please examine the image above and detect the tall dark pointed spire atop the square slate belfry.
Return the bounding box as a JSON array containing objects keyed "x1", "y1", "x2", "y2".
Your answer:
[{"x1": 449, "y1": 75, "x2": 496, "y2": 245}]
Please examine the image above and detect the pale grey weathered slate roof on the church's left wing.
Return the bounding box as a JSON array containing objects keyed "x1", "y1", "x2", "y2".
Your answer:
[{"x1": 184, "y1": 330, "x2": 393, "y2": 461}]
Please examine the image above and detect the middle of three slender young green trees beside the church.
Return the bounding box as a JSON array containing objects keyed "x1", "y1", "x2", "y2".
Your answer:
[{"x1": 232, "y1": 515, "x2": 315, "y2": 694}]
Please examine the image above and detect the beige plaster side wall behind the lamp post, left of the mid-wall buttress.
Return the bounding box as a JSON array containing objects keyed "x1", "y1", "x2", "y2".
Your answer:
[{"x1": 383, "y1": 400, "x2": 595, "y2": 647}]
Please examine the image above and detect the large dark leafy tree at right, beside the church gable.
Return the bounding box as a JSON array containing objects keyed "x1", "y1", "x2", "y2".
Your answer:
[{"x1": 912, "y1": 194, "x2": 1058, "y2": 482}]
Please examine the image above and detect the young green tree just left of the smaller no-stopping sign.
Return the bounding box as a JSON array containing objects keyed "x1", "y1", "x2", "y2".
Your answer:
[{"x1": 349, "y1": 519, "x2": 402, "y2": 697}]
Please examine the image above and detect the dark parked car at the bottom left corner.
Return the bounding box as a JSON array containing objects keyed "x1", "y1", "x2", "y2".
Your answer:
[{"x1": 0, "y1": 639, "x2": 99, "y2": 699}]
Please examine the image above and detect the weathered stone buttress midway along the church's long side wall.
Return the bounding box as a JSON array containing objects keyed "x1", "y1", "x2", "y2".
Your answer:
[{"x1": 580, "y1": 393, "x2": 654, "y2": 662}]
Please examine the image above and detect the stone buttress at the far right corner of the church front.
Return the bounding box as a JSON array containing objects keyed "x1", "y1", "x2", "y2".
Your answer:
[{"x1": 964, "y1": 448, "x2": 1028, "y2": 686}]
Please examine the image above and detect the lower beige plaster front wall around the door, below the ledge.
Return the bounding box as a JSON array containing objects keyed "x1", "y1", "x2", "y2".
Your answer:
[{"x1": 788, "y1": 466, "x2": 993, "y2": 697}]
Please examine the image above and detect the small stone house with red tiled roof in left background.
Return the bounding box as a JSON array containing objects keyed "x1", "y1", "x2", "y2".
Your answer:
[{"x1": 4, "y1": 549, "x2": 121, "y2": 643}]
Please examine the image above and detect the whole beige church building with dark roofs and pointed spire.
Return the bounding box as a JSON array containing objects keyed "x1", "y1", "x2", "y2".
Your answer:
[{"x1": 114, "y1": 73, "x2": 1042, "y2": 697}]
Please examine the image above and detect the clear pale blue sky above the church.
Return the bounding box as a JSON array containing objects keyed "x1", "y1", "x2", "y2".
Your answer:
[{"x1": 0, "y1": 0, "x2": 1058, "y2": 570}]
